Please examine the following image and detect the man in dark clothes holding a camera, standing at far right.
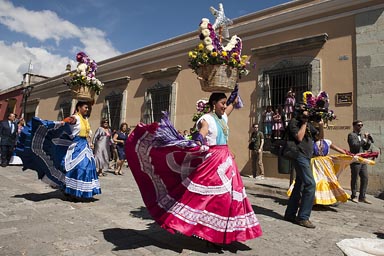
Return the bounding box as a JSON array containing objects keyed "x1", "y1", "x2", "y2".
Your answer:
[{"x1": 348, "y1": 120, "x2": 373, "y2": 204}]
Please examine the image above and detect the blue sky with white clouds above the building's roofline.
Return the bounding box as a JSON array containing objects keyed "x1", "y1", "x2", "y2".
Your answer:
[{"x1": 0, "y1": 0, "x2": 290, "y2": 90}]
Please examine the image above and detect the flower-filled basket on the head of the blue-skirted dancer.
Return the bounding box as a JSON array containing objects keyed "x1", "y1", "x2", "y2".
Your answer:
[{"x1": 64, "y1": 52, "x2": 104, "y2": 101}]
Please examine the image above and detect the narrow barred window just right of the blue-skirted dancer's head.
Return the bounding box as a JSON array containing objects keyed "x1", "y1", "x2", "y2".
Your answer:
[{"x1": 105, "y1": 94, "x2": 123, "y2": 130}]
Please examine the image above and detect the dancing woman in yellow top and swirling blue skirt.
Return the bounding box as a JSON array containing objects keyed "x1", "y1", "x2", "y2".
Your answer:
[{"x1": 16, "y1": 101, "x2": 101, "y2": 201}]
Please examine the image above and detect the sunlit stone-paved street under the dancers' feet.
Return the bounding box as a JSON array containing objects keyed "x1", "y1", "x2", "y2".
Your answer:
[{"x1": 0, "y1": 166, "x2": 384, "y2": 256}]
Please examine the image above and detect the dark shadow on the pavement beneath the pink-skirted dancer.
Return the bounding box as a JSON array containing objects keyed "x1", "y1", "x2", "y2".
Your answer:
[{"x1": 101, "y1": 222, "x2": 252, "y2": 254}]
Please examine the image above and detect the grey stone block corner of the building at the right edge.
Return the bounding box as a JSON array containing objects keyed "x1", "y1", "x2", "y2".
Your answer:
[{"x1": 354, "y1": 9, "x2": 384, "y2": 194}]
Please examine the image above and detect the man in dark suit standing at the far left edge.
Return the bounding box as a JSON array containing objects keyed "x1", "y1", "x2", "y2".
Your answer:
[{"x1": 0, "y1": 113, "x2": 17, "y2": 167}]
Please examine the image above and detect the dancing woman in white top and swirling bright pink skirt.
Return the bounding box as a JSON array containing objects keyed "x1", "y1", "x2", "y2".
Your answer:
[{"x1": 126, "y1": 93, "x2": 262, "y2": 244}]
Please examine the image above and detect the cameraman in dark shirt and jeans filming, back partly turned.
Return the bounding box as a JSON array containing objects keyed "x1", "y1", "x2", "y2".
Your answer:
[{"x1": 284, "y1": 104, "x2": 324, "y2": 228}]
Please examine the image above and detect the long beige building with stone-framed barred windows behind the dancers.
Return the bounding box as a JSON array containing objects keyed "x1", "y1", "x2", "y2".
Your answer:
[{"x1": 12, "y1": 0, "x2": 384, "y2": 193}]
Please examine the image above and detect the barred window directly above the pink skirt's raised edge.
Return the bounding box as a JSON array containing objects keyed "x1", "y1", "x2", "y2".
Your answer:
[{"x1": 143, "y1": 83, "x2": 172, "y2": 123}]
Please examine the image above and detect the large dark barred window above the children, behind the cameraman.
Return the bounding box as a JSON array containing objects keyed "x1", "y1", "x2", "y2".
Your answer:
[{"x1": 262, "y1": 65, "x2": 312, "y2": 109}]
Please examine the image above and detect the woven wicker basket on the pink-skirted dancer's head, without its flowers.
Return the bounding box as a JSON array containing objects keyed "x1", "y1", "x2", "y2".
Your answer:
[{"x1": 197, "y1": 65, "x2": 238, "y2": 92}]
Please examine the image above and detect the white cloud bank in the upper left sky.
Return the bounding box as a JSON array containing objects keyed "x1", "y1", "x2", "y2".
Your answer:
[{"x1": 0, "y1": 0, "x2": 121, "y2": 90}]
